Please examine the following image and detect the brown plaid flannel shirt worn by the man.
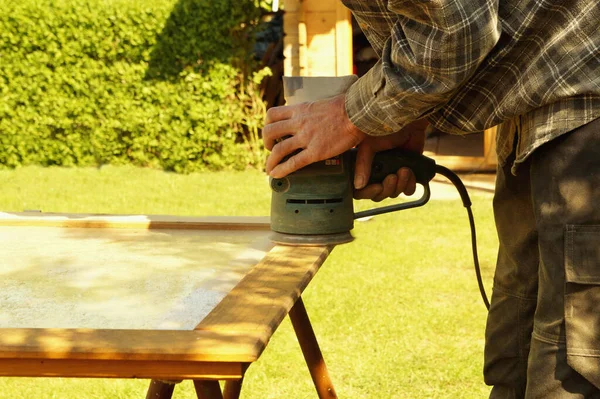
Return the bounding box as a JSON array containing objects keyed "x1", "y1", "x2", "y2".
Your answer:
[{"x1": 343, "y1": 0, "x2": 600, "y2": 167}]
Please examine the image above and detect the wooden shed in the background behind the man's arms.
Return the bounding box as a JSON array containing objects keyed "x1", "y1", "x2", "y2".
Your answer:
[{"x1": 283, "y1": 0, "x2": 497, "y2": 171}]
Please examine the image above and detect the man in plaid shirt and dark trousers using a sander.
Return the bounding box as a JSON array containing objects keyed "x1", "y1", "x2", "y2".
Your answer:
[{"x1": 263, "y1": 0, "x2": 600, "y2": 399}]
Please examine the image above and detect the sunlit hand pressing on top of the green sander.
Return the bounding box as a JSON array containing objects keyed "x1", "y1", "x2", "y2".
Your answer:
[{"x1": 263, "y1": 94, "x2": 367, "y2": 178}]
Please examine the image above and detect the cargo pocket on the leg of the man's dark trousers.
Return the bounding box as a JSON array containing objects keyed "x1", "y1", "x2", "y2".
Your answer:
[{"x1": 565, "y1": 225, "x2": 600, "y2": 388}]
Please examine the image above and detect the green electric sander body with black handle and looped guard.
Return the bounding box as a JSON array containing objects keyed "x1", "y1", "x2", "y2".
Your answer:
[{"x1": 270, "y1": 149, "x2": 436, "y2": 245}]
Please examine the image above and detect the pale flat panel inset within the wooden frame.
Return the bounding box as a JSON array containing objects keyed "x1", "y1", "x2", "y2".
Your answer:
[{"x1": 0, "y1": 227, "x2": 271, "y2": 329}]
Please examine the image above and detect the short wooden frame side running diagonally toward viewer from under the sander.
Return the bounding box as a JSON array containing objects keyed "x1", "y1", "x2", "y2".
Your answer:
[{"x1": 196, "y1": 246, "x2": 333, "y2": 360}]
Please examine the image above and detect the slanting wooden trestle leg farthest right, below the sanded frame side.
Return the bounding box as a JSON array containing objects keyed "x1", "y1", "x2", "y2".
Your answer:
[{"x1": 289, "y1": 298, "x2": 337, "y2": 399}]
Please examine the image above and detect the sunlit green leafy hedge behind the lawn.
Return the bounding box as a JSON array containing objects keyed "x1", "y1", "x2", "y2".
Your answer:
[{"x1": 0, "y1": 0, "x2": 264, "y2": 172}]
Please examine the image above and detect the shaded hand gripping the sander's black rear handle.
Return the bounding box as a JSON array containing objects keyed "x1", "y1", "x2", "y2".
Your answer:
[{"x1": 354, "y1": 120, "x2": 427, "y2": 202}]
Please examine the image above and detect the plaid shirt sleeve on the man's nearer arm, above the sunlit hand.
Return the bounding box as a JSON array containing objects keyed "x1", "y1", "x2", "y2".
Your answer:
[{"x1": 344, "y1": 0, "x2": 501, "y2": 136}]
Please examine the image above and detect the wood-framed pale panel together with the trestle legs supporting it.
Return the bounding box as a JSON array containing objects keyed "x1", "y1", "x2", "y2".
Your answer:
[{"x1": 0, "y1": 213, "x2": 336, "y2": 398}]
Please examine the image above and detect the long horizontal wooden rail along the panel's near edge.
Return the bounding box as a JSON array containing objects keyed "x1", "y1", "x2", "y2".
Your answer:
[{"x1": 0, "y1": 330, "x2": 264, "y2": 363}]
